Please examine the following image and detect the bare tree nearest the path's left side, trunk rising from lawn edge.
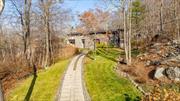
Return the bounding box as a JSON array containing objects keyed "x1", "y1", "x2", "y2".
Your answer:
[{"x1": 39, "y1": 0, "x2": 68, "y2": 67}]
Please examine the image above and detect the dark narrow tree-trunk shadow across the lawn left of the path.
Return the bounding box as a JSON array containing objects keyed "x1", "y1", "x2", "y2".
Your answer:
[{"x1": 24, "y1": 75, "x2": 37, "y2": 101}]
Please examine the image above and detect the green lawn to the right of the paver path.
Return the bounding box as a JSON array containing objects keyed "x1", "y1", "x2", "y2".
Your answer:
[{"x1": 85, "y1": 48, "x2": 141, "y2": 101}]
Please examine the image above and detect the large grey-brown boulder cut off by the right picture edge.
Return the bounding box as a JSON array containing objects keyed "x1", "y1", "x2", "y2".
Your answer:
[{"x1": 165, "y1": 67, "x2": 180, "y2": 81}]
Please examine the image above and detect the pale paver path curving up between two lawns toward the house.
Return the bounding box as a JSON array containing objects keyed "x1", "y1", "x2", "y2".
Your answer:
[{"x1": 58, "y1": 54, "x2": 85, "y2": 101}]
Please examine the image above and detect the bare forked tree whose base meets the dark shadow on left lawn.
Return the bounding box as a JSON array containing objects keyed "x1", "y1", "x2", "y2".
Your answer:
[{"x1": 11, "y1": 0, "x2": 33, "y2": 67}]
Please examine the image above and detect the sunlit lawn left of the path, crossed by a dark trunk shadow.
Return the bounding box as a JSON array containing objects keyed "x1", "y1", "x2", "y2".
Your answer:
[{"x1": 7, "y1": 60, "x2": 69, "y2": 101}]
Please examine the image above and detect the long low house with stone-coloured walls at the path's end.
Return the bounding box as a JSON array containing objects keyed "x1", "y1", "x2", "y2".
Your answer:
[{"x1": 67, "y1": 29, "x2": 123, "y2": 49}]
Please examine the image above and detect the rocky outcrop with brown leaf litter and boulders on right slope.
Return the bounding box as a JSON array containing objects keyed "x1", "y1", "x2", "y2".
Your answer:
[{"x1": 141, "y1": 40, "x2": 180, "y2": 81}]
